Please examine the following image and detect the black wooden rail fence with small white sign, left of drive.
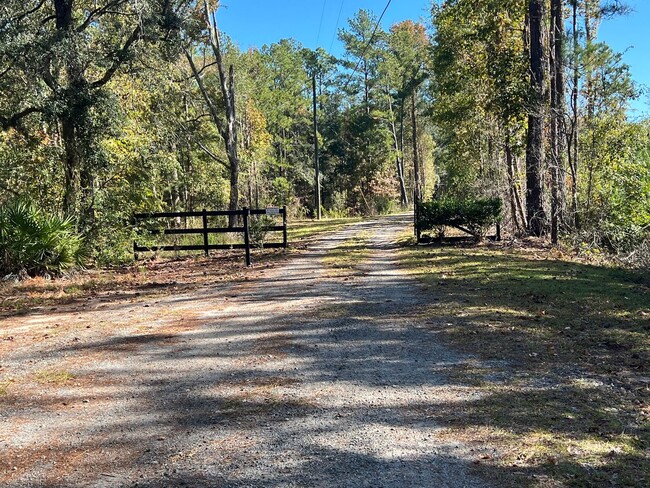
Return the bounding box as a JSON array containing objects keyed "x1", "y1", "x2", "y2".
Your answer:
[{"x1": 133, "y1": 206, "x2": 288, "y2": 266}]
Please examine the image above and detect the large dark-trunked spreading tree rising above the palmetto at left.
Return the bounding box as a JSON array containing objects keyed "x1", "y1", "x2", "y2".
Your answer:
[{"x1": 0, "y1": 0, "x2": 190, "y2": 221}]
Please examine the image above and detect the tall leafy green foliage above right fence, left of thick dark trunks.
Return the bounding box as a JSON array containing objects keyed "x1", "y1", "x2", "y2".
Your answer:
[{"x1": 430, "y1": 0, "x2": 529, "y2": 195}]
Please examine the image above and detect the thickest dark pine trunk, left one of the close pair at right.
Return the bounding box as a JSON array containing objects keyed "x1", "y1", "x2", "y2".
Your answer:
[{"x1": 526, "y1": 0, "x2": 546, "y2": 236}]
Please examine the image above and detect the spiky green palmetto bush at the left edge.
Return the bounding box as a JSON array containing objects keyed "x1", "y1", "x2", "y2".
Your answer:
[{"x1": 0, "y1": 200, "x2": 83, "y2": 276}]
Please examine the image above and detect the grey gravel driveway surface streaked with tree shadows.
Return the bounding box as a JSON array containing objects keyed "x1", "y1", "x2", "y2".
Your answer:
[{"x1": 0, "y1": 216, "x2": 488, "y2": 488}]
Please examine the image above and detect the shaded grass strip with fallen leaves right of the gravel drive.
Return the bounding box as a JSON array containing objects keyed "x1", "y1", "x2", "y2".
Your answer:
[{"x1": 401, "y1": 239, "x2": 650, "y2": 487}]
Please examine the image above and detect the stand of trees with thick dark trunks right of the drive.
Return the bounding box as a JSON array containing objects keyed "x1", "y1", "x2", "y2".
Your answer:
[{"x1": 431, "y1": 0, "x2": 650, "y2": 260}]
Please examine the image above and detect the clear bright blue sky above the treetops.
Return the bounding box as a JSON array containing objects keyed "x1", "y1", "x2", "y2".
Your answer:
[{"x1": 218, "y1": 0, "x2": 650, "y2": 116}]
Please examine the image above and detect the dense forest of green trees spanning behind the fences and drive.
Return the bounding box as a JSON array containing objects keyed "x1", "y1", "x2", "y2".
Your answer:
[{"x1": 0, "y1": 0, "x2": 650, "y2": 263}]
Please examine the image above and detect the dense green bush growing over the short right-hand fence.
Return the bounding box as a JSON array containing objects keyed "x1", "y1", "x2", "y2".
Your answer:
[{"x1": 418, "y1": 198, "x2": 503, "y2": 237}]
